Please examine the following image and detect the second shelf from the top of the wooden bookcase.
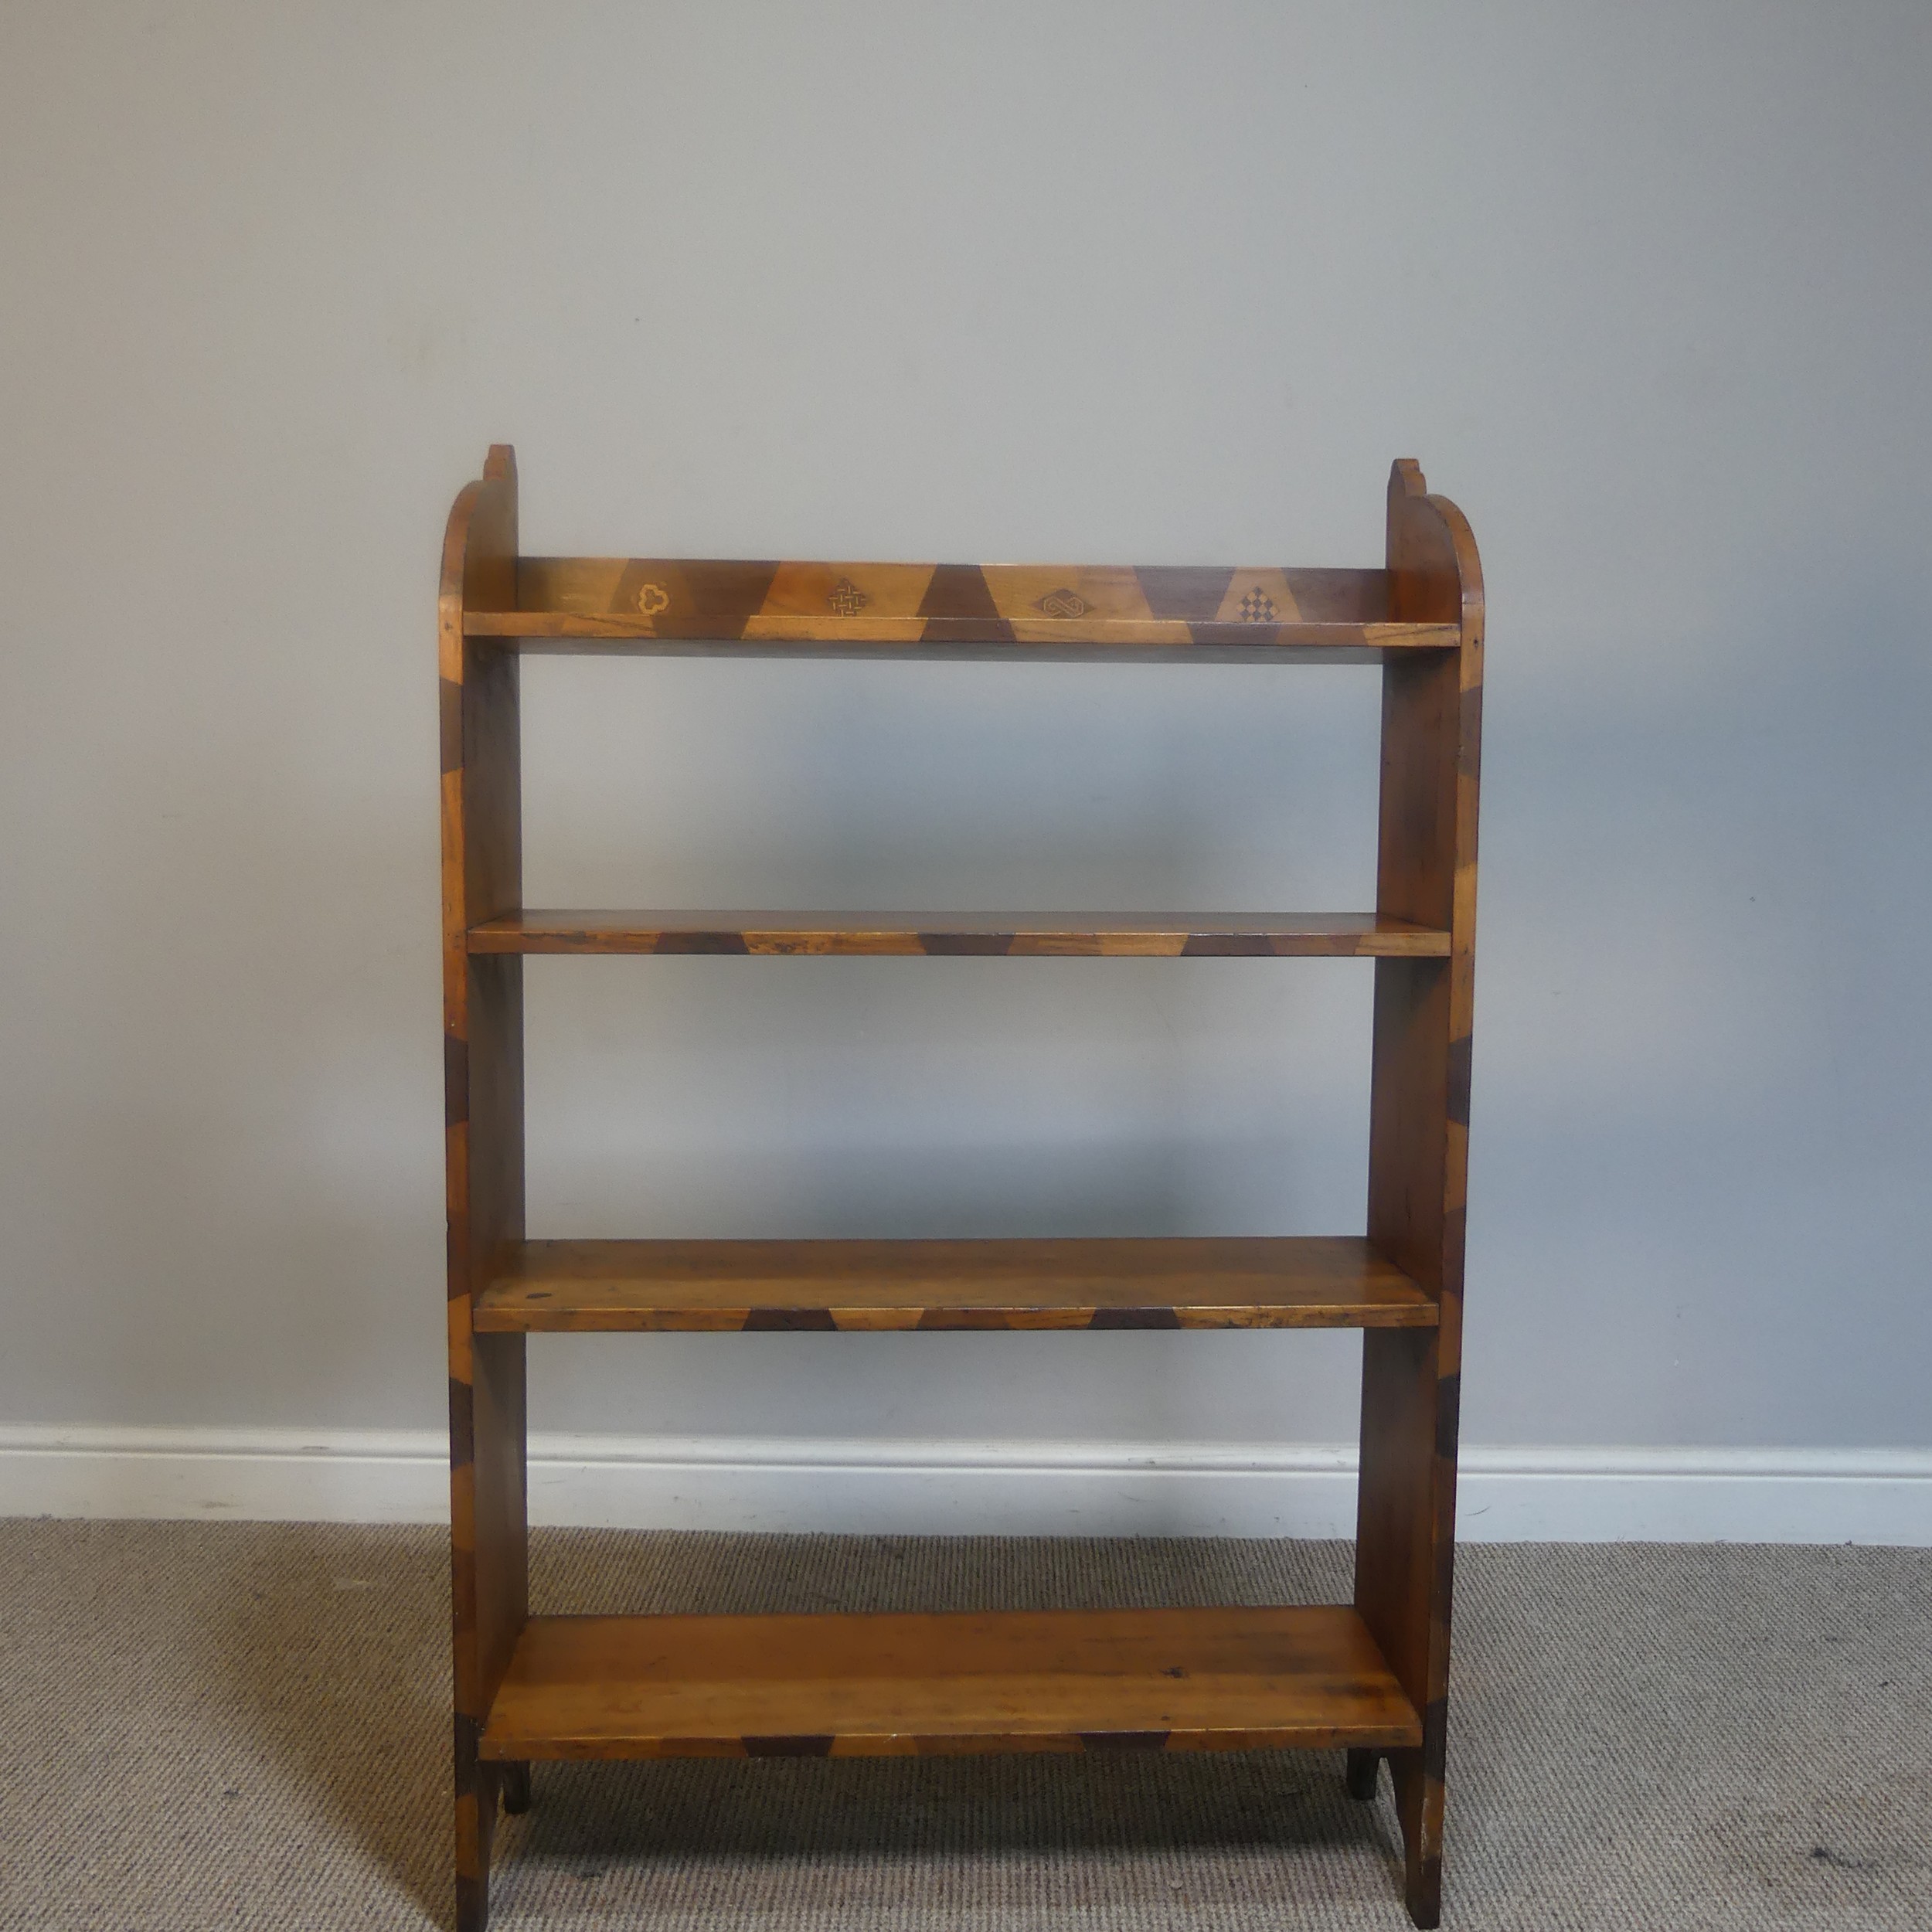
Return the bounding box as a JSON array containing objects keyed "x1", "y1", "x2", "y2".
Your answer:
[{"x1": 470, "y1": 910, "x2": 1449, "y2": 958}]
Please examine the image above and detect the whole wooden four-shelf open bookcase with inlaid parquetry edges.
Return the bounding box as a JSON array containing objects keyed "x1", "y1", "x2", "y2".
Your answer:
[{"x1": 439, "y1": 447, "x2": 1482, "y2": 1932}]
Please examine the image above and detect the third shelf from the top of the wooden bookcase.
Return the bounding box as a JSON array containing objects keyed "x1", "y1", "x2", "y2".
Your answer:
[{"x1": 471, "y1": 1235, "x2": 1437, "y2": 1335}]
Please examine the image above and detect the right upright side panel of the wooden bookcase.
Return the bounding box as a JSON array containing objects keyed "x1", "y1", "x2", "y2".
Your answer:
[{"x1": 1355, "y1": 462, "x2": 1484, "y2": 1927}]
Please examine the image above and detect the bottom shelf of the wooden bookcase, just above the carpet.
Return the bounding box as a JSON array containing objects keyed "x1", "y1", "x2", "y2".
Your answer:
[{"x1": 481, "y1": 1606, "x2": 1422, "y2": 1760}]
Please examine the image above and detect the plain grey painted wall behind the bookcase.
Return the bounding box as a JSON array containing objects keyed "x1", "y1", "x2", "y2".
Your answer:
[{"x1": 0, "y1": 0, "x2": 1932, "y2": 1445}]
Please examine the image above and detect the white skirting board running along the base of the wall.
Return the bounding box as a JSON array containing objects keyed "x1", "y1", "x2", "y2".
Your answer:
[{"x1": 0, "y1": 1426, "x2": 1932, "y2": 1548}]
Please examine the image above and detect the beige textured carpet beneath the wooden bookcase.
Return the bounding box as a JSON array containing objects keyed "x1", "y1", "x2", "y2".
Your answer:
[{"x1": 0, "y1": 1522, "x2": 1932, "y2": 1932}]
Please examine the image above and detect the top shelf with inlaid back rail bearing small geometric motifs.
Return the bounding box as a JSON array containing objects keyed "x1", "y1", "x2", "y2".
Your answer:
[{"x1": 464, "y1": 556, "x2": 1463, "y2": 663}]
